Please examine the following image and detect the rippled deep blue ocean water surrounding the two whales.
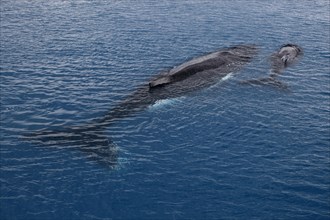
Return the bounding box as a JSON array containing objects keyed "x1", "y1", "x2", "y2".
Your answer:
[{"x1": 0, "y1": 0, "x2": 330, "y2": 220}]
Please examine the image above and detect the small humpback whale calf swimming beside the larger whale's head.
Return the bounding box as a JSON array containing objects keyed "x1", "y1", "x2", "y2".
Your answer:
[{"x1": 241, "y1": 44, "x2": 303, "y2": 89}]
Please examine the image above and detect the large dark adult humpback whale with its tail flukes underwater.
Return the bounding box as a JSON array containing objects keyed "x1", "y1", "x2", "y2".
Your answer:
[{"x1": 26, "y1": 45, "x2": 258, "y2": 167}]
